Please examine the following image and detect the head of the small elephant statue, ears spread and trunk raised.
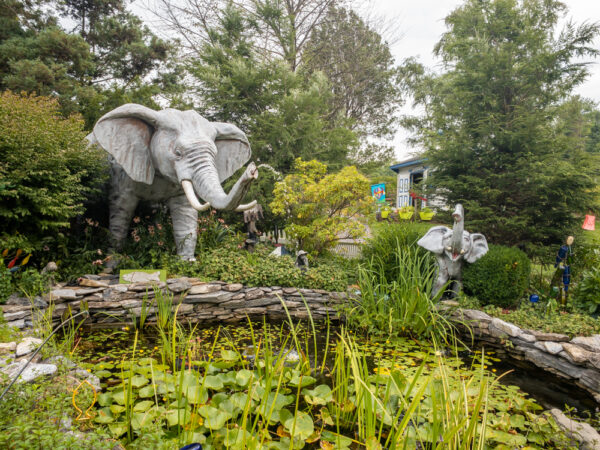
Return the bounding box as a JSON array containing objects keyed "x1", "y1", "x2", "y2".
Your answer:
[{"x1": 417, "y1": 204, "x2": 488, "y2": 263}]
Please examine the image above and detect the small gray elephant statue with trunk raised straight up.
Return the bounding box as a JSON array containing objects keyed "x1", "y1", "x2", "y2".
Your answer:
[{"x1": 417, "y1": 204, "x2": 488, "y2": 296}]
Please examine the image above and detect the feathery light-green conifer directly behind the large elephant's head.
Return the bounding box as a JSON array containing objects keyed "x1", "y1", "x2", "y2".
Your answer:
[{"x1": 187, "y1": 5, "x2": 357, "y2": 176}]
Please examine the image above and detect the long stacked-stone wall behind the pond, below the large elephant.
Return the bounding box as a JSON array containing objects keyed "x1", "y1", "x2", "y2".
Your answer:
[{"x1": 0, "y1": 275, "x2": 345, "y2": 328}]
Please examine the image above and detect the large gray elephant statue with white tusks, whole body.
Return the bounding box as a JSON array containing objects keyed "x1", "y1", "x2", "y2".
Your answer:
[{"x1": 88, "y1": 104, "x2": 258, "y2": 260}]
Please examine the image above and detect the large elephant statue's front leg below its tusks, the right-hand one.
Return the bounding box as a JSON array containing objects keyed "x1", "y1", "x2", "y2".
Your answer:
[{"x1": 169, "y1": 195, "x2": 198, "y2": 261}]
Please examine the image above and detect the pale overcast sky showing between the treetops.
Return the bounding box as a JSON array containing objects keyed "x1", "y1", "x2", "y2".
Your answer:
[{"x1": 132, "y1": 0, "x2": 600, "y2": 159}]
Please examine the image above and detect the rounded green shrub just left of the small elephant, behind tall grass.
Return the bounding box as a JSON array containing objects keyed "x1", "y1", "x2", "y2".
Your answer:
[{"x1": 362, "y1": 223, "x2": 429, "y2": 280}]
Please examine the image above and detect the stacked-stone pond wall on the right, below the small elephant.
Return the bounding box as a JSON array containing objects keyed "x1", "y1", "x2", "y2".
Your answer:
[{"x1": 452, "y1": 309, "x2": 600, "y2": 403}]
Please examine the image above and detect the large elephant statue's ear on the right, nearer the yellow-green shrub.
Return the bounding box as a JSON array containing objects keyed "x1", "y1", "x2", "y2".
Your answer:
[{"x1": 212, "y1": 122, "x2": 252, "y2": 183}]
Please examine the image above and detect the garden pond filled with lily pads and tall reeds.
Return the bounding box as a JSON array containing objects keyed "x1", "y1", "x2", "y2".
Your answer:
[{"x1": 65, "y1": 322, "x2": 595, "y2": 449}]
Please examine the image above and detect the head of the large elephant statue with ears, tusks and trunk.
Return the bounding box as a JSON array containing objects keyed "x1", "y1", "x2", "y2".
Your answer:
[{"x1": 90, "y1": 104, "x2": 258, "y2": 211}]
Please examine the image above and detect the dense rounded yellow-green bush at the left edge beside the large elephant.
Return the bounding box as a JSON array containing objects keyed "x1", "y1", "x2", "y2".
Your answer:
[{"x1": 0, "y1": 92, "x2": 106, "y2": 251}]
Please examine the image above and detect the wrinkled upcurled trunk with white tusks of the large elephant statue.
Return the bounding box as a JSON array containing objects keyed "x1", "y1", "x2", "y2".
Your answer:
[{"x1": 177, "y1": 148, "x2": 258, "y2": 211}]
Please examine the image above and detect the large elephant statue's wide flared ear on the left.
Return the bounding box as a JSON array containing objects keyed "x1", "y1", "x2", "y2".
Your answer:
[{"x1": 93, "y1": 104, "x2": 158, "y2": 184}]
